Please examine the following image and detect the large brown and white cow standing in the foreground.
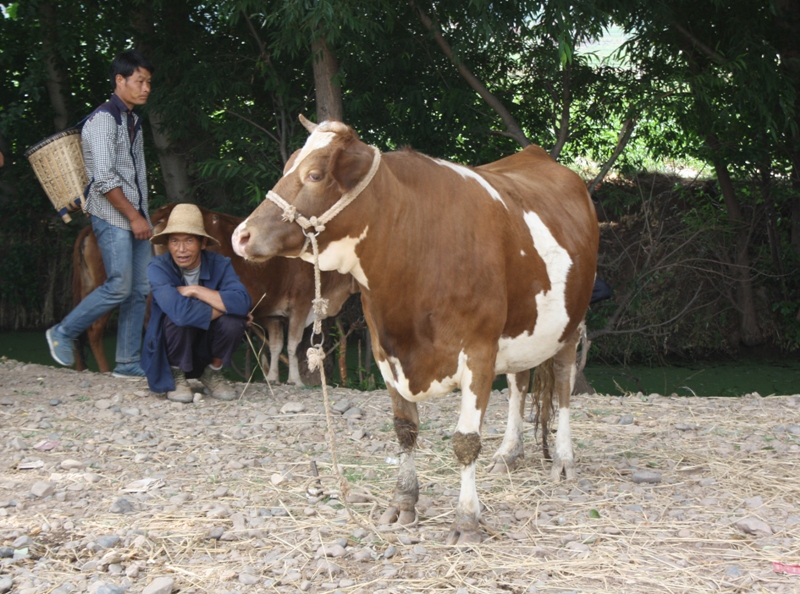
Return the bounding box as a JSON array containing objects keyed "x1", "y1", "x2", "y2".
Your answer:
[{"x1": 233, "y1": 117, "x2": 599, "y2": 544}]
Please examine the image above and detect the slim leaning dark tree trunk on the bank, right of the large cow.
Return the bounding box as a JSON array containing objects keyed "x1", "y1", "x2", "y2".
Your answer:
[{"x1": 708, "y1": 135, "x2": 764, "y2": 346}]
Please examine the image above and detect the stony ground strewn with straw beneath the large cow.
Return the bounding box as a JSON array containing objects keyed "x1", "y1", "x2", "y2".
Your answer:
[{"x1": 0, "y1": 360, "x2": 800, "y2": 594}]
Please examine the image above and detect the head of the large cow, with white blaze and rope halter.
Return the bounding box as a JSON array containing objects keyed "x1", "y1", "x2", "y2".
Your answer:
[{"x1": 233, "y1": 115, "x2": 375, "y2": 261}]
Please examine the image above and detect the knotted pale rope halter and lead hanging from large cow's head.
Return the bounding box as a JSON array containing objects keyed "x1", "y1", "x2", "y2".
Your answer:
[{"x1": 267, "y1": 146, "x2": 381, "y2": 528}]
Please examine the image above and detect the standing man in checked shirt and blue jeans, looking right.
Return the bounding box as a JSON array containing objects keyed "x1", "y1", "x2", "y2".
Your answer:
[{"x1": 47, "y1": 50, "x2": 154, "y2": 377}]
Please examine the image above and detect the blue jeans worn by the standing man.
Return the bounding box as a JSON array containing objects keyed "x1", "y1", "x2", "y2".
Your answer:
[{"x1": 58, "y1": 216, "x2": 153, "y2": 365}]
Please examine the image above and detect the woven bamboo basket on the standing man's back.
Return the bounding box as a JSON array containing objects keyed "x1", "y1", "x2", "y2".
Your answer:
[{"x1": 25, "y1": 128, "x2": 89, "y2": 223}]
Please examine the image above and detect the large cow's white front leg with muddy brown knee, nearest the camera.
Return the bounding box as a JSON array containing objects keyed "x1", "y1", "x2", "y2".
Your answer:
[{"x1": 447, "y1": 357, "x2": 494, "y2": 544}]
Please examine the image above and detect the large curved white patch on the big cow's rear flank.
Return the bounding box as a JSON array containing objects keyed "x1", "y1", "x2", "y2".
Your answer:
[{"x1": 495, "y1": 212, "x2": 572, "y2": 373}]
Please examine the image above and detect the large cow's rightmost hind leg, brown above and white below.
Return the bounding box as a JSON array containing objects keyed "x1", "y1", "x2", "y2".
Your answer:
[{"x1": 550, "y1": 327, "x2": 581, "y2": 482}]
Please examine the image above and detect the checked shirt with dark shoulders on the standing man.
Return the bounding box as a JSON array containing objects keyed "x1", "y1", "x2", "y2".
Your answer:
[{"x1": 81, "y1": 94, "x2": 152, "y2": 230}]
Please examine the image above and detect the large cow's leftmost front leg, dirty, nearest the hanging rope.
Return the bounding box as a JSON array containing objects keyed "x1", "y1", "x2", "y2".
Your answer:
[{"x1": 379, "y1": 387, "x2": 419, "y2": 525}]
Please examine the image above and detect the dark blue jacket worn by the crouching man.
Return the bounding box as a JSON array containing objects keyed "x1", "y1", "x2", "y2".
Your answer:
[{"x1": 142, "y1": 250, "x2": 250, "y2": 394}]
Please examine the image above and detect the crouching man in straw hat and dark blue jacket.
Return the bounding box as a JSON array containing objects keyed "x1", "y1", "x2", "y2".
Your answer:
[{"x1": 142, "y1": 204, "x2": 250, "y2": 403}]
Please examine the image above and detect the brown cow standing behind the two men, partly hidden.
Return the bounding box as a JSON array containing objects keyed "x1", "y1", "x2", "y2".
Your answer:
[{"x1": 72, "y1": 204, "x2": 357, "y2": 386}]
